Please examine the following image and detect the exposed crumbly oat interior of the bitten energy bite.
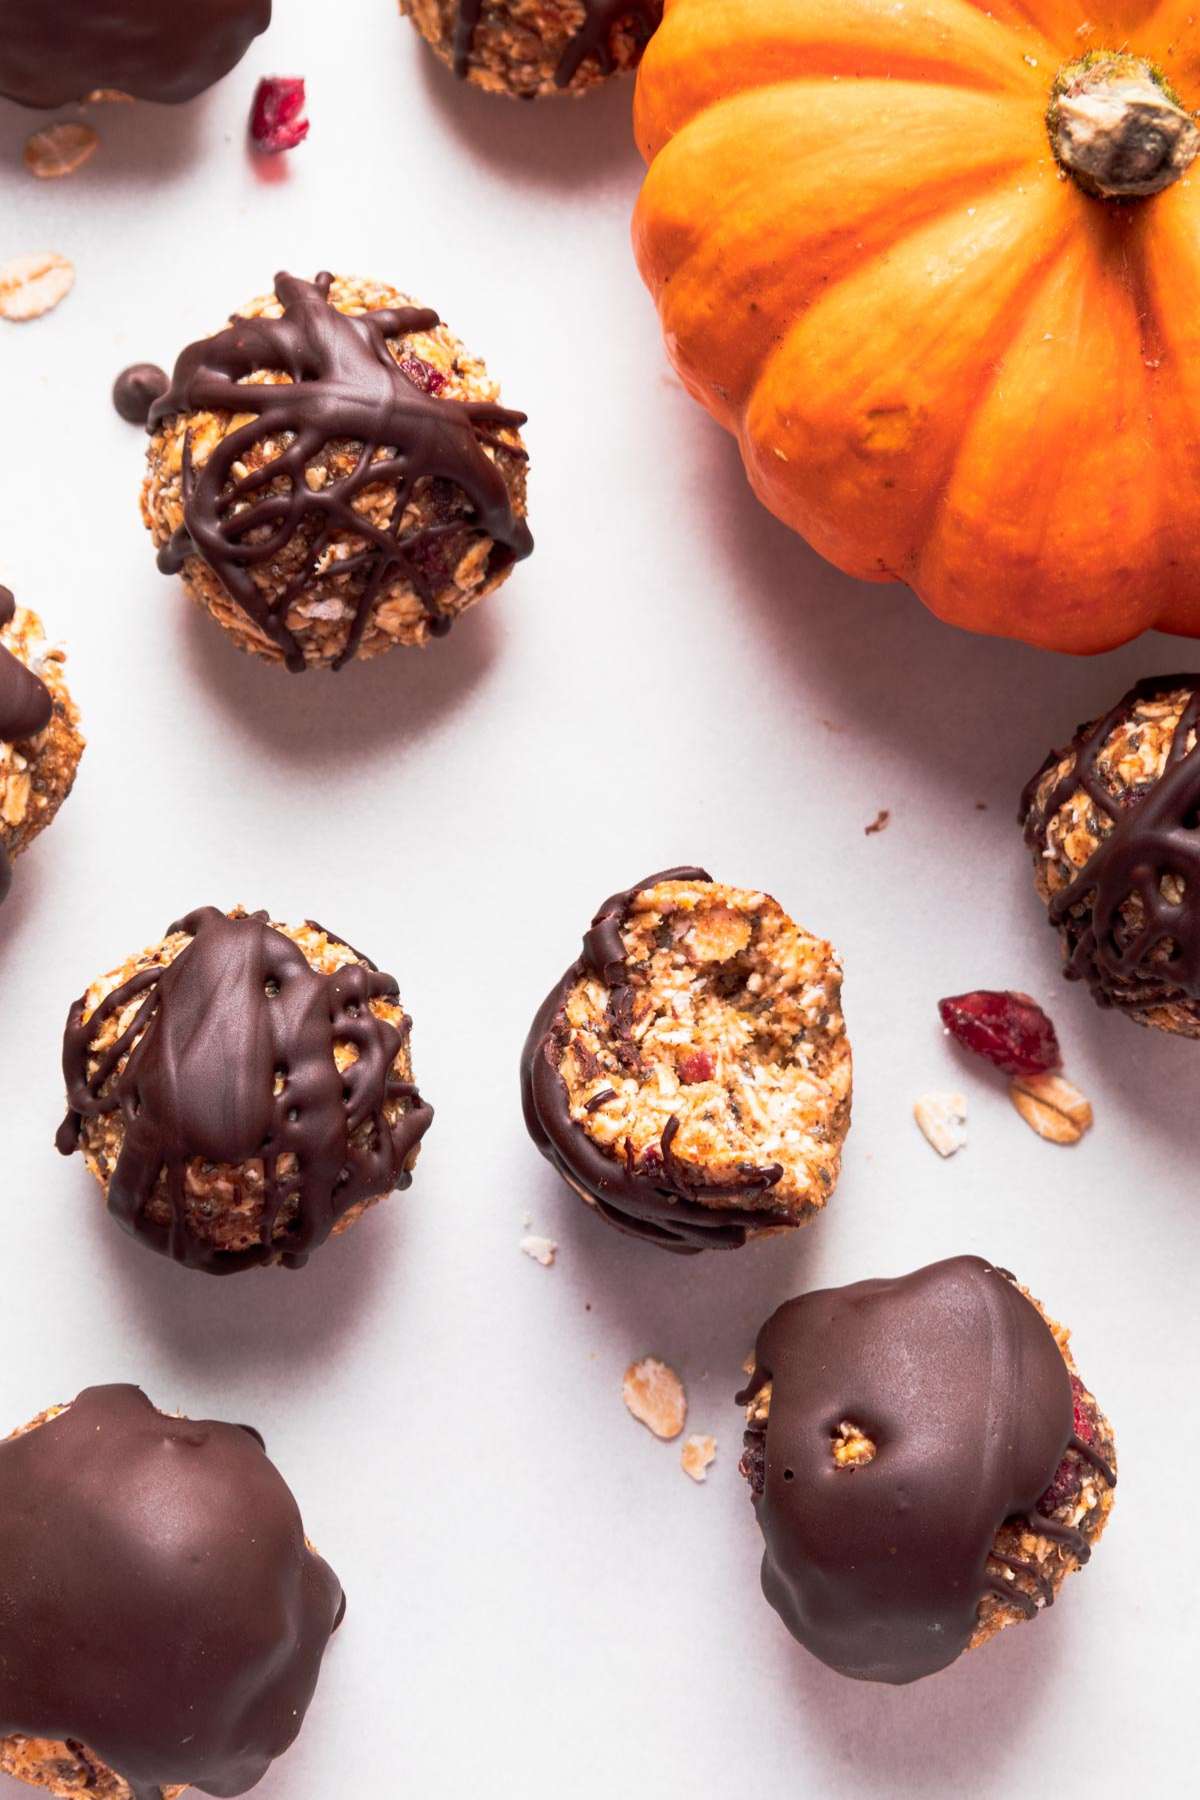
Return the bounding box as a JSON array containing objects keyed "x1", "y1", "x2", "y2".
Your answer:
[{"x1": 556, "y1": 880, "x2": 851, "y2": 1224}]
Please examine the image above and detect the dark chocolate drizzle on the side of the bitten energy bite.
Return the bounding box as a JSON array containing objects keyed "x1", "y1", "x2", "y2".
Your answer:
[{"x1": 522, "y1": 868, "x2": 783, "y2": 1255}]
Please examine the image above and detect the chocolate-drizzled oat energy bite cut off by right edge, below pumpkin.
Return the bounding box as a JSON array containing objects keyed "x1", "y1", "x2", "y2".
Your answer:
[{"x1": 1020, "y1": 675, "x2": 1200, "y2": 1037}]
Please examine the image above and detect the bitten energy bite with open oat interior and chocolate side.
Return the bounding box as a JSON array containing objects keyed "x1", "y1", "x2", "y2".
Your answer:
[{"x1": 522, "y1": 868, "x2": 851, "y2": 1251}]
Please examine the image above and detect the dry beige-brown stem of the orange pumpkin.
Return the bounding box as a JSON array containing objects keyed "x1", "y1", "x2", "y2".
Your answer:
[{"x1": 1047, "y1": 52, "x2": 1200, "y2": 200}]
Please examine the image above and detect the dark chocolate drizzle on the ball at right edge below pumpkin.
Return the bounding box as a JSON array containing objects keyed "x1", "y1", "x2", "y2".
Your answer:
[{"x1": 1020, "y1": 675, "x2": 1200, "y2": 1008}]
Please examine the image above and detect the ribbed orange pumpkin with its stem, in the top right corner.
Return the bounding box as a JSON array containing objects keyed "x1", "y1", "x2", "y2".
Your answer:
[{"x1": 635, "y1": 0, "x2": 1200, "y2": 652}]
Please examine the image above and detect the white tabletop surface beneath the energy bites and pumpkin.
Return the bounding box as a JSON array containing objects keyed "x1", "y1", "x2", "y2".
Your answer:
[{"x1": 0, "y1": 0, "x2": 1200, "y2": 1800}]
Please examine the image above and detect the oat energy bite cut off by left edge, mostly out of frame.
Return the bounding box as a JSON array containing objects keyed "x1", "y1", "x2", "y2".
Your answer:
[{"x1": 0, "y1": 587, "x2": 83, "y2": 900}]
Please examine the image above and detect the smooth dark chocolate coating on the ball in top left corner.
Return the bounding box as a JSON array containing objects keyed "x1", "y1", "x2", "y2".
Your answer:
[{"x1": 0, "y1": 0, "x2": 272, "y2": 106}]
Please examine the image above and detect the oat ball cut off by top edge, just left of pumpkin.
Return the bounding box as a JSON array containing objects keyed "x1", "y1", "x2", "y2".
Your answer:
[{"x1": 399, "y1": 0, "x2": 664, "y2": 101}]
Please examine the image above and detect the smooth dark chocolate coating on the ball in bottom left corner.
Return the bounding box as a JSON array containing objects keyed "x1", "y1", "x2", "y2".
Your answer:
[{"x1": 0, "y1": 1386, "x2": 344, "y2": 1800}]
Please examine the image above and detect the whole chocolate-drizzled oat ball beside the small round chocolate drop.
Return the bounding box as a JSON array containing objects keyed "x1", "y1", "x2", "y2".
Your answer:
[{"x1": 142, "y1": 262, "x2": 533, "y2": 671}]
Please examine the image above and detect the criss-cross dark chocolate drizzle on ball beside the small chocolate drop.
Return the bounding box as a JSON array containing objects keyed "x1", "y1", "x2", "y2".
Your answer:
[{"x1": 148, "y1": 272, "x2": 533, "y2": 671}]
